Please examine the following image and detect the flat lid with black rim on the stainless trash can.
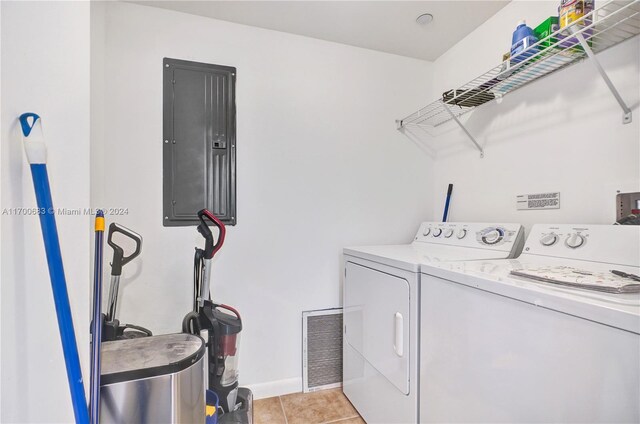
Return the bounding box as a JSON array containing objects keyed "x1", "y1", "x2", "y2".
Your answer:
[{"x1": 100, "y1": 333, "x2": 205, "y2": 386}]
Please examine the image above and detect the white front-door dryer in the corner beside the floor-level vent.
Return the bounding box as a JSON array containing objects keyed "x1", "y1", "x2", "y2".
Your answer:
[{"x1": 343, "y1": 222, "x2": 524, "y2": 424}]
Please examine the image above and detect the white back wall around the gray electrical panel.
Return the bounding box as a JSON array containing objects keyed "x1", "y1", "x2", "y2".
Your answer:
[{"x1": 92, "y1": 3, "x2": 433, "y2": 396}]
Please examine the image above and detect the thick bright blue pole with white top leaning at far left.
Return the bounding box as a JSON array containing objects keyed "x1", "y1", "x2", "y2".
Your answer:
[{"x1": 20, "y1": 113, "x2": 89, "y2": 424}]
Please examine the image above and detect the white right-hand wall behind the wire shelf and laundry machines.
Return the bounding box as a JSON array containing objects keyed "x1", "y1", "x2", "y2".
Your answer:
[{"x1": 429, "y1": 1, "x2": 640, "y2": 226}]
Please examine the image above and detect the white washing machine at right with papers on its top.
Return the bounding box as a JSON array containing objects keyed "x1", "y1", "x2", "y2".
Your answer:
[{"x1": 420, "y1": 225, "x2": 640, "y2": 423}]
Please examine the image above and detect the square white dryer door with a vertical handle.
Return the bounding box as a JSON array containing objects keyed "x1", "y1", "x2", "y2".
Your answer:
[{"x1": 344, "y1": 262, "x2": 410, "y2": 394}]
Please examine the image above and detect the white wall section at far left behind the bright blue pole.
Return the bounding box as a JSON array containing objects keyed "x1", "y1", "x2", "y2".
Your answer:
[{"x1": 0, "y1": 2, "x2": 91, "y2": 423}]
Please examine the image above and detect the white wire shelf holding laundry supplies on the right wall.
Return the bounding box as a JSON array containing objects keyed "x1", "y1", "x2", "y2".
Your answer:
[{"x1": 398, "y1": 0, "x2": 640, "y2": 130}]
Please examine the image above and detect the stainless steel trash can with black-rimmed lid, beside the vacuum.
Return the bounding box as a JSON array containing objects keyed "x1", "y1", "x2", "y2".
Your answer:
[{"x1": 100, "y1": 334, "x2": 206, "y2": 424}]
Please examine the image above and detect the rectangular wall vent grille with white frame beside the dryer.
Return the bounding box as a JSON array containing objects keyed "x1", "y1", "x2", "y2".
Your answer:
[{"x1": 302, "y1": 308, "x2": 342, "y2": 393}]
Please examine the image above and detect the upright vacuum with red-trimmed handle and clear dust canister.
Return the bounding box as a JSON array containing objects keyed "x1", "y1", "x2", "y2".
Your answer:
[{"x1": 182, "y1": 209, "x2": 246, "y2": 416}]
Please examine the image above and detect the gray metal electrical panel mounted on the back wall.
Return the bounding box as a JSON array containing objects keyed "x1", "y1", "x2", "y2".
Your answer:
[{"x1": 162, "y1": 58, "x2": 236, "y2": 227}]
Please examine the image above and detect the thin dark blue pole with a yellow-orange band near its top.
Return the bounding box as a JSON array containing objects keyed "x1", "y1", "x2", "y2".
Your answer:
[{"x1": 89, "y1": 210, "x2": 104, "y2": 424}]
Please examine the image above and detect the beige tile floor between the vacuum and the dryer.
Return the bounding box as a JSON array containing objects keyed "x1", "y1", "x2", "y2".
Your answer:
[{"x1": 253, "y1": 389, "x2": 366, "y2": 424}]
